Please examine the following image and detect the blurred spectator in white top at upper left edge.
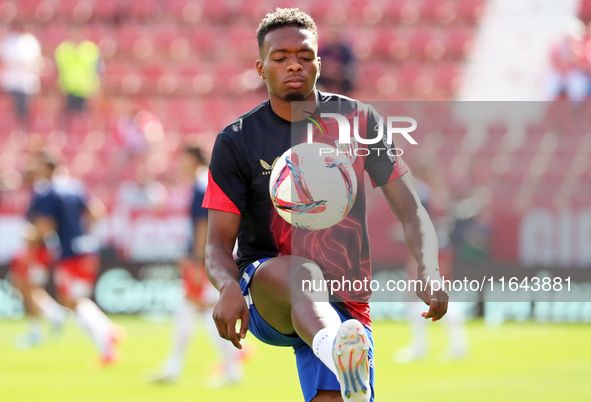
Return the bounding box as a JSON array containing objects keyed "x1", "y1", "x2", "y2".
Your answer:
[{"x1": 0, "y1": 23, "x2": 43, "y2": 131}]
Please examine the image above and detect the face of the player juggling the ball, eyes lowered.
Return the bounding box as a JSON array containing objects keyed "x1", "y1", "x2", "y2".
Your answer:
[{"x1": 257, "y1": 27, "x2": 320, "y2": 102}]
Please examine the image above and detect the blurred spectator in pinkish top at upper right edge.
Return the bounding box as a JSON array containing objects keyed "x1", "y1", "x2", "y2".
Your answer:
[{"x1": 547, "y1": 18, "x2": 591, "y2": 101}]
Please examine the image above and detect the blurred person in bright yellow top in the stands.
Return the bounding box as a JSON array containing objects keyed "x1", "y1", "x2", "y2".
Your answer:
[{"x1": 55, "y1": 26, "x2": 102, "y2": 129}]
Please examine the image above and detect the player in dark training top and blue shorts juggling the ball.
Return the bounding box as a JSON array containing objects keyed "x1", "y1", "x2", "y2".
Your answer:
[{"x1": 203, "y1": 9, "x2": 447, "y2": 402}]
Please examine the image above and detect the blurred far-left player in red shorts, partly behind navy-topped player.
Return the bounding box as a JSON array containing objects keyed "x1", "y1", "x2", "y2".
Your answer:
[{"x1": 10, "y1": 159, "x2": 66, "y2": 349}]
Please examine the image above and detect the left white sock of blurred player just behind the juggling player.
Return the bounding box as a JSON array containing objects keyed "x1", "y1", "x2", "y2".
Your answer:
[{"x1": 164, "y1": 299, "x2": 197, "y2": 376}]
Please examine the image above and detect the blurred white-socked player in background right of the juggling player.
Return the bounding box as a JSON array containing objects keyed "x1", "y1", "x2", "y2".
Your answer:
[{"x1": 394, "y1": 161, "x2": 468, "y2": 363}]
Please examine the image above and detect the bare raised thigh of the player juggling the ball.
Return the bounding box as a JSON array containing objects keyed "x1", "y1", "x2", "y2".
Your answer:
[{"x1": 250, "y1": 256, "x2": 323, "y2": 335}]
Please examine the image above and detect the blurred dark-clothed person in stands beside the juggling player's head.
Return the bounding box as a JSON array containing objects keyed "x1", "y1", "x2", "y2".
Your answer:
[{"x1": 318, "y1": 26, "x2": 355, "y2": 95}]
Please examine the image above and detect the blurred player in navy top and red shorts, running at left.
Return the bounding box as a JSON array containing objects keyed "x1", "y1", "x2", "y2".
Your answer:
[{"x1": 30, "y1": 154, "x2": 121, "y2": 364}]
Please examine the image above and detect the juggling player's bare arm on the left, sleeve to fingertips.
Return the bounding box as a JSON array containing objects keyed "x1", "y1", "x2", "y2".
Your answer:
[{"x1": 205, "y1": 209, "x2": 250, "y2": 349}]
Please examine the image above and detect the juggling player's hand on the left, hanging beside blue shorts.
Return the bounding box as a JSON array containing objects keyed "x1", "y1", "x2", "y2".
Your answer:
[{"x1": 213, "y1": 282, "x2": 250, "y2": 349}]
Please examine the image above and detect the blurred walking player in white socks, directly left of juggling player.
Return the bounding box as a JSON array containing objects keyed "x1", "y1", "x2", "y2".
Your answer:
[{"x1": 148, "y1": 145, "x2": 242, "y2": 386}]
